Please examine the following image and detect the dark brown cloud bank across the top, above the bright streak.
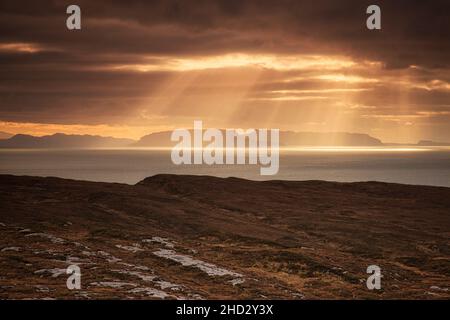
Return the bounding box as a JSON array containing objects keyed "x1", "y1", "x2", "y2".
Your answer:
[{"x1": 0, "y1": 0, "x2": 450, "y2": 63}]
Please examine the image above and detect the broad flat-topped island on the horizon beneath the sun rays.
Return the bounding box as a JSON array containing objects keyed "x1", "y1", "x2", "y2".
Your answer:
[{"x1": 133, "y1": 130, "x2": 383, "y2": 147}]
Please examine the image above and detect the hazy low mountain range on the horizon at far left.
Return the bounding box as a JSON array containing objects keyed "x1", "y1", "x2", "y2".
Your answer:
[{"x1": 0, "y1": 133, "x2": 135, "y2": 148}]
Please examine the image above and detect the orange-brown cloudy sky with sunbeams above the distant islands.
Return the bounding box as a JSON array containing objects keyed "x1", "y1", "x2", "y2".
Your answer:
[{"x1": 0, "y1": 0, "x2": 450, "y2": 143}]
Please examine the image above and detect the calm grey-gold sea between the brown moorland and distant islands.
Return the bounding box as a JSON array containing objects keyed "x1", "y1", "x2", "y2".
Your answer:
[{"x1": 0, "y1": 148, "x2": 450, "y2": 187}]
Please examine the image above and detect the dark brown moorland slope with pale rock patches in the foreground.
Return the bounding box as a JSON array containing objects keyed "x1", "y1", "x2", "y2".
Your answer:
[{"x1": 0, "y1": 175, "x2": 450, "y2": 299}]
